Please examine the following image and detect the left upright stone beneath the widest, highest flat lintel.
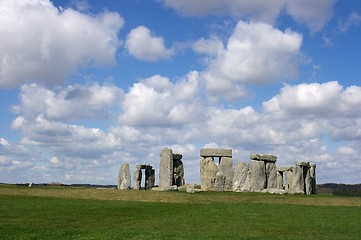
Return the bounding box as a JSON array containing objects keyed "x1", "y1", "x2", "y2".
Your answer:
[{"x1": 200, "y1": 157, "x2": 218, "y2": 191}]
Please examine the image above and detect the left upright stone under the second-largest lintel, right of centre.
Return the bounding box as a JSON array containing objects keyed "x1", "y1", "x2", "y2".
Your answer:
[{"x1": 250, "y1": 160, "x2": 267, "y2": 191}]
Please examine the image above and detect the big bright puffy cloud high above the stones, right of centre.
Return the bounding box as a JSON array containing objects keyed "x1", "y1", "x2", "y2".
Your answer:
[{"x1": 198, "y1": 21, "x2": 302, "y2": 99}]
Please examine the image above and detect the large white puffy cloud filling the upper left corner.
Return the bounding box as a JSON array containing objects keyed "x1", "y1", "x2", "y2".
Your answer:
[{"x1": 0, "y1": 0, "x2": 124, "y2": 88}]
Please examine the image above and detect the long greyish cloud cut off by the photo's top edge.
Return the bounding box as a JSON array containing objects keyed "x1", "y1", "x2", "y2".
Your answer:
[{"x1": 161, "y1": 0, "x2": 336, "y2": 32}]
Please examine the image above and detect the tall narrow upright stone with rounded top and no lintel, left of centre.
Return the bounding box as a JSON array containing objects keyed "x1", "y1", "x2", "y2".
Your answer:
[{"x1": 159, "y1": 148, "x2": 173, "y2": 190}]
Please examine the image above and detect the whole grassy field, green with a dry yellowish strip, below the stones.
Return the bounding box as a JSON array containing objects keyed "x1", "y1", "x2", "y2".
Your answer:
[{"x1": 0, "y1": 185, "x2": 361, "y2": 239}]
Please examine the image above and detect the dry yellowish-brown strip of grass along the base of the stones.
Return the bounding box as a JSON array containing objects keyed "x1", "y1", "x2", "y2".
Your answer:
[{"x1": 0, "y1": 185, "x2": 361, "y2": 207}]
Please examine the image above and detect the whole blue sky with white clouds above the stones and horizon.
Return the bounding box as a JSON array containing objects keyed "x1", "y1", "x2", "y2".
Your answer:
[{"x1": 0, "y1": 0, "x2": 361, "y2": 184}]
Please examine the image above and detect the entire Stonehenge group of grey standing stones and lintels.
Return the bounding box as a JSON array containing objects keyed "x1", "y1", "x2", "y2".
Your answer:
[{"x1": 118, "y1": 145, "x2": 316, "y2": 195}]
